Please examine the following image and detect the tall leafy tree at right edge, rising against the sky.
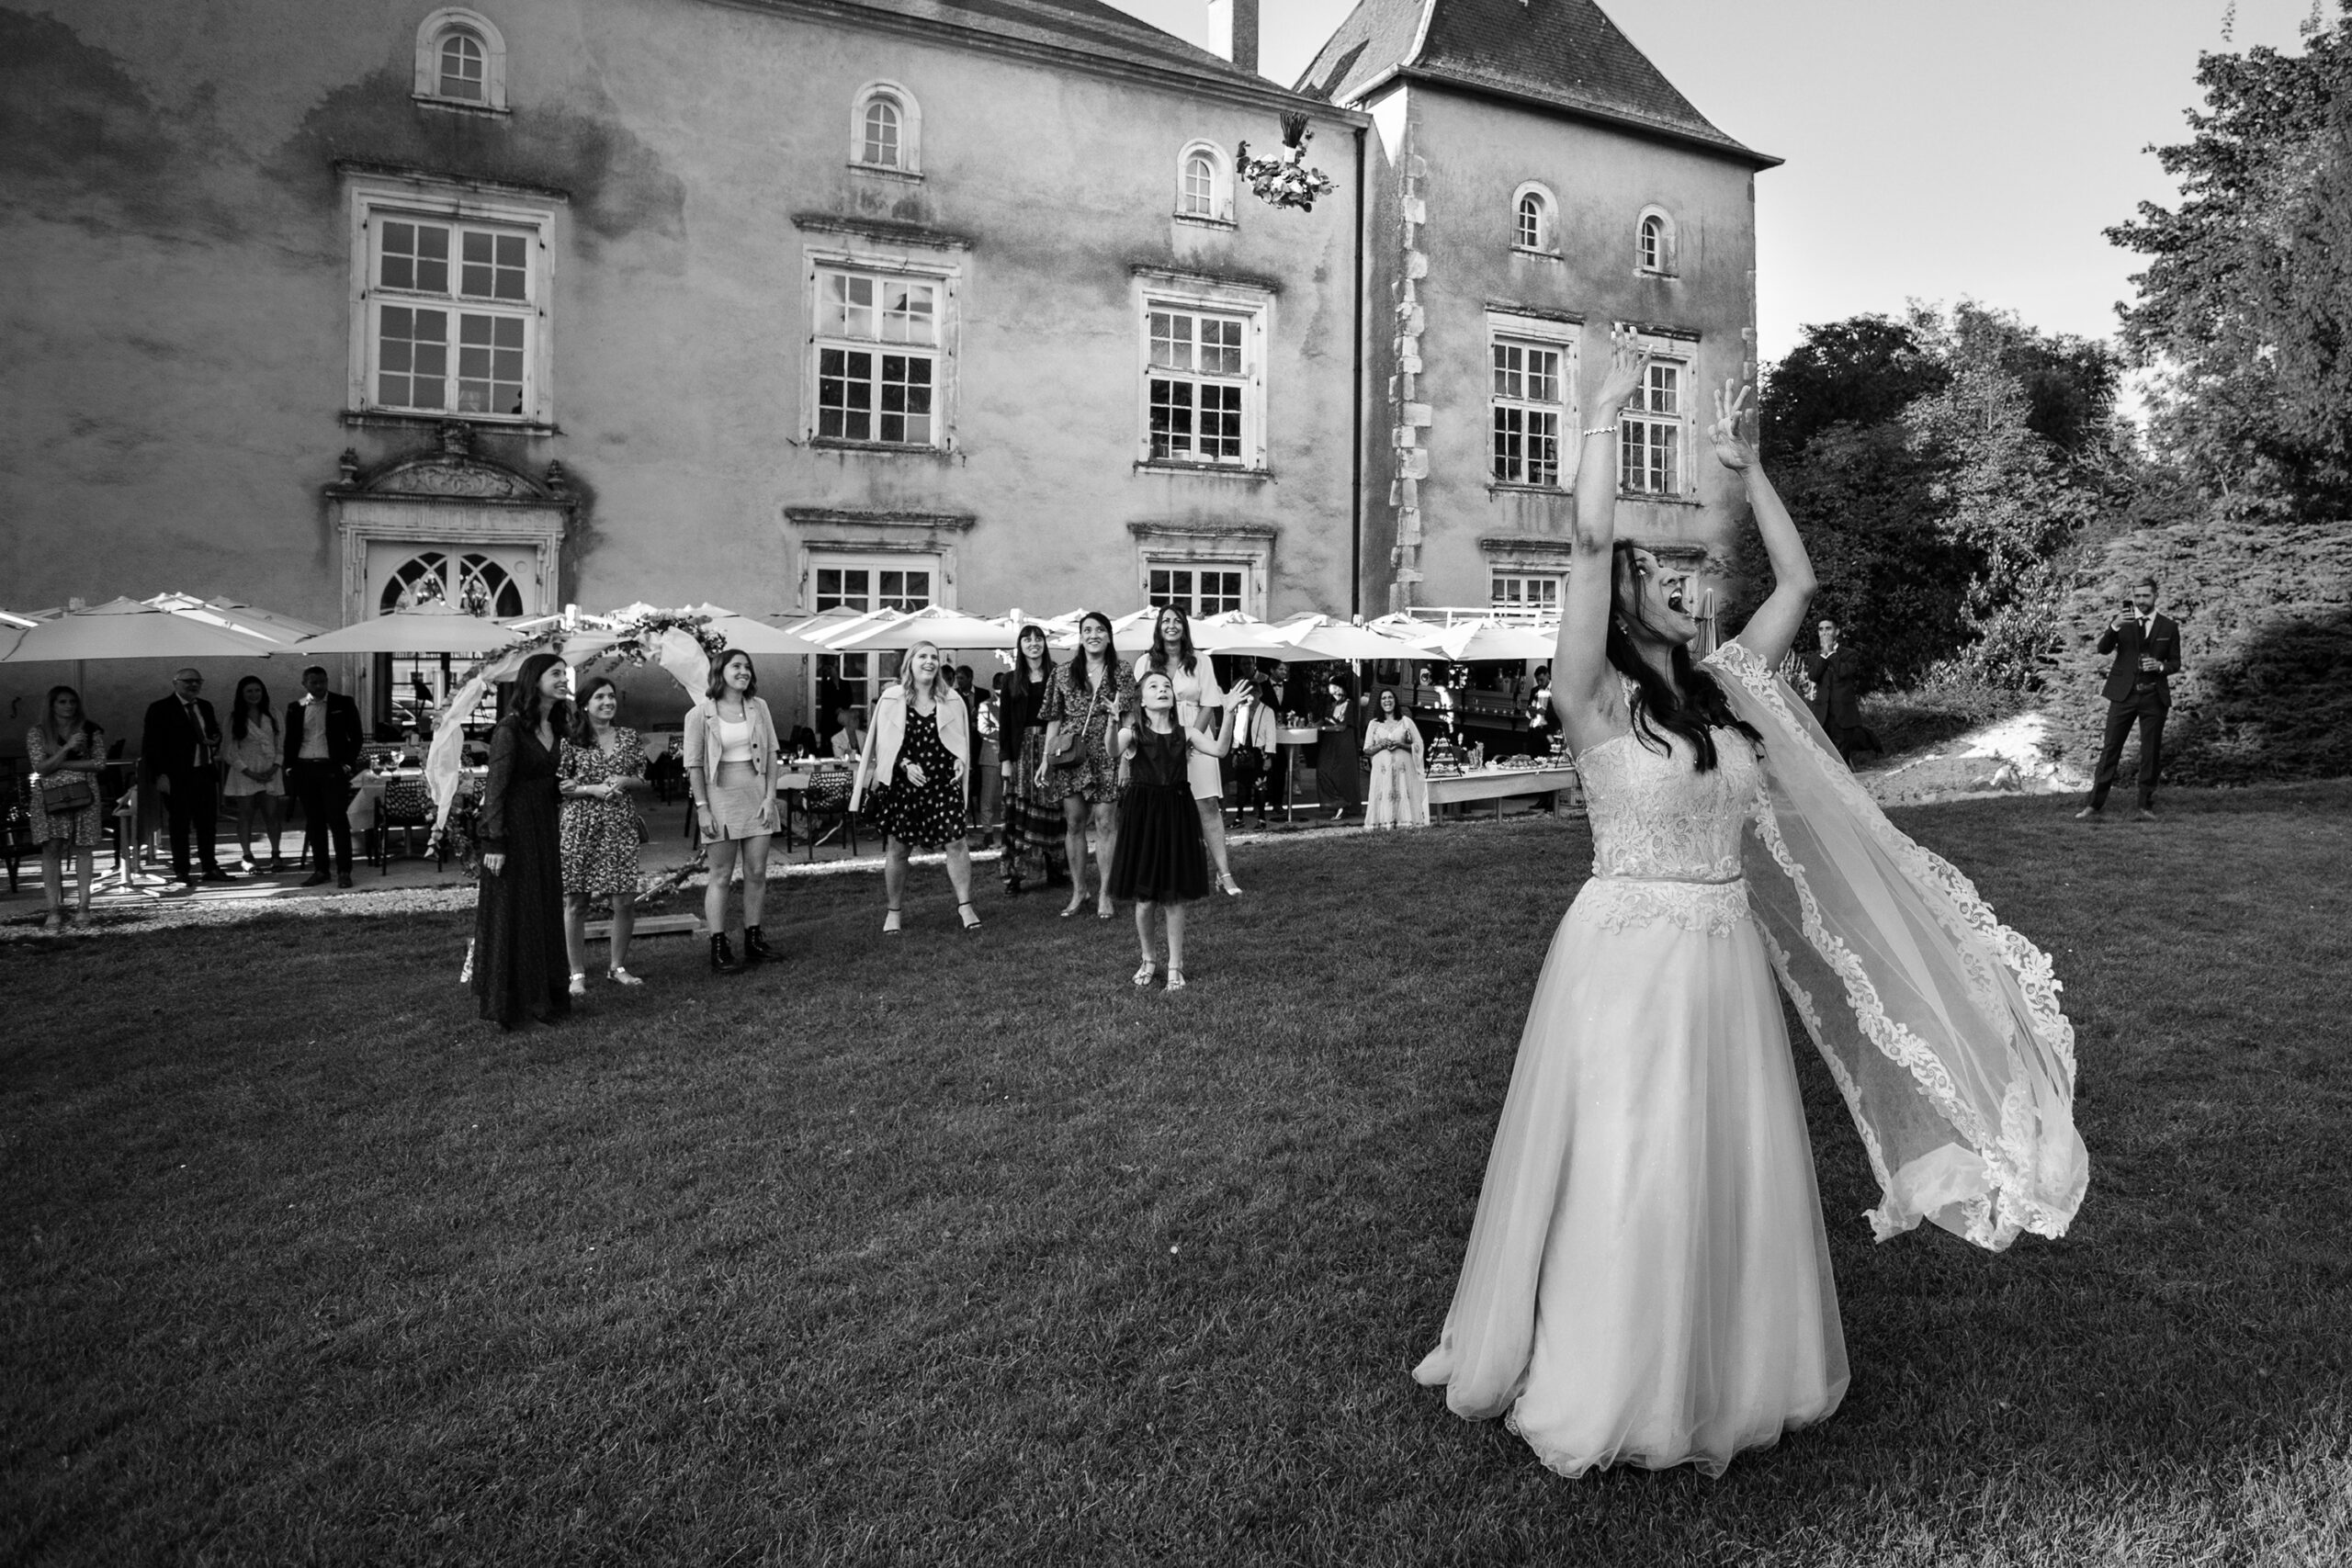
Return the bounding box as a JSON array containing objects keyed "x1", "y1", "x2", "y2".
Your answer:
[{"x1": 2108, "y1": 0, "x2": 2352, "y2": 520}]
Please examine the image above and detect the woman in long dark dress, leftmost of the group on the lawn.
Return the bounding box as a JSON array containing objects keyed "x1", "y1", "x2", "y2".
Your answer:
[{"x1": 473, "y1": 653, "x2": 571, "y2": 1030}]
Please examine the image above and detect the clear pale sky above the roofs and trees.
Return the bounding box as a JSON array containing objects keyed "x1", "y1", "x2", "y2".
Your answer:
[{"x1": 1113, "y1": 0, "x2": 2335, "y2": 362}]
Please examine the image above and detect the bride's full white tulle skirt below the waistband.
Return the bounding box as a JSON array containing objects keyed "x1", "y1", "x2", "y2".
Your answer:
[{"x1": 1414, "y1": 879, "x2": 1847, "y2": 1476}]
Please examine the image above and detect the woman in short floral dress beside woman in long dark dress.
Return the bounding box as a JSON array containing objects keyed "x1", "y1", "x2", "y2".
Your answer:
[{"x1": 555, "y1": 674, "x2": 644, "y2": 997}]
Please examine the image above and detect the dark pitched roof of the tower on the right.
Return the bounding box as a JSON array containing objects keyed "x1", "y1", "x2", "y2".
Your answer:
[{"x1": 1298, "y1": 0, "x2": 1781, "y2": 164}]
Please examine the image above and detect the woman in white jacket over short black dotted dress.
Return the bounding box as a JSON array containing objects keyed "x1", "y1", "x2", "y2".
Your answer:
[{"x1": 849, "y1": 642, "x2": 981, "y2": 936}]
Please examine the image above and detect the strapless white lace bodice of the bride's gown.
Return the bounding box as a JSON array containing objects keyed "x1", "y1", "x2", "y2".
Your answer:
[{"x1": 1576, "y1": 728, "x2": 1759, "y2": 882}]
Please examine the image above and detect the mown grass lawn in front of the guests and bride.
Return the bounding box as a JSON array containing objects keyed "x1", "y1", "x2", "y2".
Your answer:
[{"x1": 0, "y1": 785, "x2": 2352, "y2": 1568}]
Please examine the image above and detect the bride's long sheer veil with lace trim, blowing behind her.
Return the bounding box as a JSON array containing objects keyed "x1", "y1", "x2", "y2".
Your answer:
[{"x1": 1705, "y1": 642, "x2": 2091, "y2": 1248}]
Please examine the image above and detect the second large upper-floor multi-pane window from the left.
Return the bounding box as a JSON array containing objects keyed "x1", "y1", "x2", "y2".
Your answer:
[{"x1": 816, "y1": 268, "x2": 941, "y2": 446}]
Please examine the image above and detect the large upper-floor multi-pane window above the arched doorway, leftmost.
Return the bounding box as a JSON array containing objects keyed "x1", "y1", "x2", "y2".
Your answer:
[{"x1": 369, "y1": 214, "x2": 538, "y2": 416}]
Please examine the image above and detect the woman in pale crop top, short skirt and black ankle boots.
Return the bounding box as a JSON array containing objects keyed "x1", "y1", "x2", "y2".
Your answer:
[{"x1": 687, "y1": 649, "x2": 776, "y2": 976}]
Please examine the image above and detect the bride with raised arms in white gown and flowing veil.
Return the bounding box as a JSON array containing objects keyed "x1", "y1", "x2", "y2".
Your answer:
[{"x1": 1414, "y1": 329, "x2": 2088, "y2": 1476}]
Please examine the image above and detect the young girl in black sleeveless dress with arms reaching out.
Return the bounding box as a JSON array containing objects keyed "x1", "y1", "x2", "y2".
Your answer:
[{"x1": 1103, "y1": 670, "x2": 1249, "y2": 992}]
